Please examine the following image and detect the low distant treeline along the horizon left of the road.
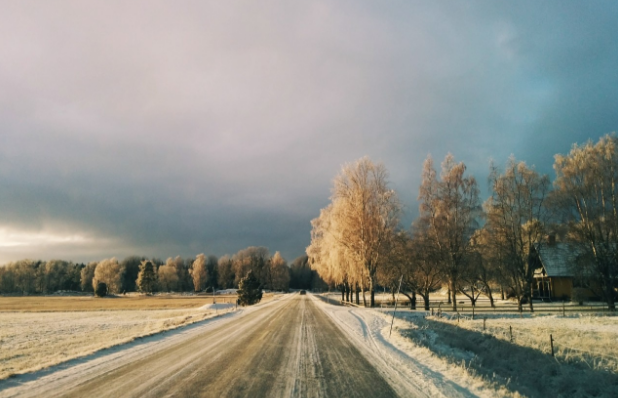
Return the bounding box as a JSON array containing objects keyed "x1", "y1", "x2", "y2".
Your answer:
[{"x1": 0, "y1": 247, "x2": 323, "y2": 294}]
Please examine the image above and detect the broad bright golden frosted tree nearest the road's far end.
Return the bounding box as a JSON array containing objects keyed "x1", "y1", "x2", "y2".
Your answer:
[{"x1": 307, "y1": 157, "x2": 401, "y2": 307}]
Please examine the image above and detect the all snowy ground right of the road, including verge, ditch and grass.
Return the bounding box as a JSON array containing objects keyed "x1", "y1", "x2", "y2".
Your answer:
[{"x1": 312, "y1": 296, "x2": 618, "y2": 397}]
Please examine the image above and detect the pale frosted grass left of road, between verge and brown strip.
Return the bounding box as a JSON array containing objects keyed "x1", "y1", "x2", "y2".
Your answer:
[{"x1": 0, "y1": 309, "x2": 229, "y2": 379}]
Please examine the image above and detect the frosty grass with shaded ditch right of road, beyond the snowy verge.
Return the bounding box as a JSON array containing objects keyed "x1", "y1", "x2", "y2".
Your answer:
[{"x1": 398, "y1": 311, "x2": 618, "y2": 397}]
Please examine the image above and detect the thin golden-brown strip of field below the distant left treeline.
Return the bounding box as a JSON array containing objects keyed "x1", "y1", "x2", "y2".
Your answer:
[{"x1": 0, "y1": 294, "x2": 238, "y2": 316}]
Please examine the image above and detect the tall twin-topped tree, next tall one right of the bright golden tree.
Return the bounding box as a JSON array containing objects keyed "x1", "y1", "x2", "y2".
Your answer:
[{"x1": 418, "y1": 153, "x2": 480, "y2": 310}]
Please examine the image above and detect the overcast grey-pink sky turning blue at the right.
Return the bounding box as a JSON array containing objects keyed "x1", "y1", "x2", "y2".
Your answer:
[{"x1": 0, "y1": 0, "x2": 618, "y2": 263}]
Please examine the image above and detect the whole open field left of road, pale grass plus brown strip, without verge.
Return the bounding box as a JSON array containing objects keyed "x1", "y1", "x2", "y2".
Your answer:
[{"x1": 0, "y1": 293, "x2": 282, "y2": 379}]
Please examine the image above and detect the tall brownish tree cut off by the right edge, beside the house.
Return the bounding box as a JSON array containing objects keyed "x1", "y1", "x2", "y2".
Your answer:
[{"x1": 554, "y1": 134, "x2": 618, "y2": 311}]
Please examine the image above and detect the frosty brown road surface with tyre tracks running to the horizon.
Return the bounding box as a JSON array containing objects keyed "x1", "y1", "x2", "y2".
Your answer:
[{"x1": 0, "y1": 294, "x2": 397, "y2": 398}]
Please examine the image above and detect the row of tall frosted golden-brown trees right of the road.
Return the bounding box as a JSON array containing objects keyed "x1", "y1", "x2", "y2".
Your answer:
[{"x1": 307, "y1": 134, "x2": 618, "y2": 310}]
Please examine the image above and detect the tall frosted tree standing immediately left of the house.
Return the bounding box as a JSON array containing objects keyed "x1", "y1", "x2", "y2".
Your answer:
[{"x1": 484, "y1": 156, "x2": 550, "y2": 311}]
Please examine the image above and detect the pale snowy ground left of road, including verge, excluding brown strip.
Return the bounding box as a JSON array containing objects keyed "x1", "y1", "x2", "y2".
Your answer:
[{"x1": 0, "y1": 295, "x2": 290, "y2": 397}]
